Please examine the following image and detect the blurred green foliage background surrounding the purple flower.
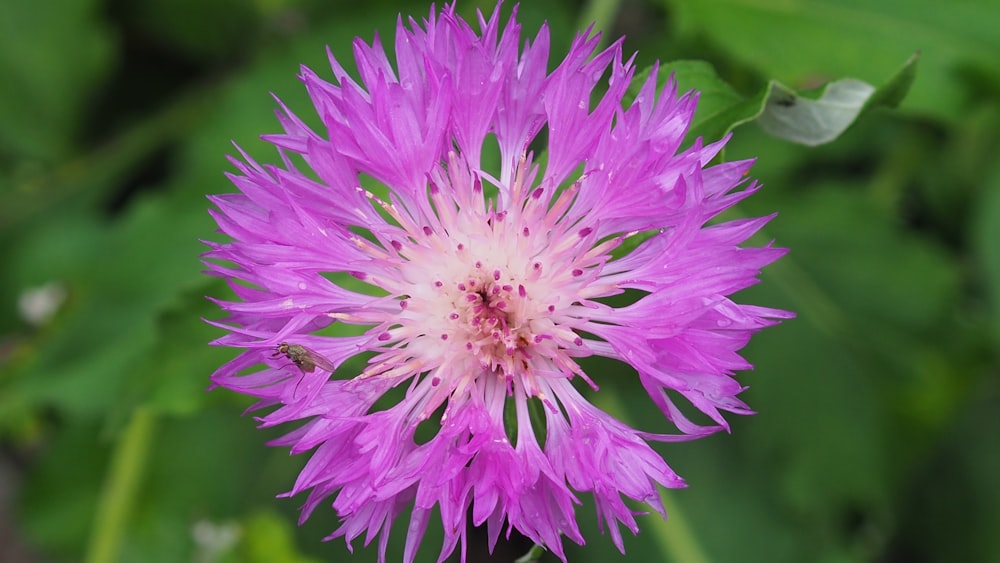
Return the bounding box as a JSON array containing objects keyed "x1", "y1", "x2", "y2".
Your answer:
[{"x1": 0, "y1": 0, "x2": 1000, "y2": 563}]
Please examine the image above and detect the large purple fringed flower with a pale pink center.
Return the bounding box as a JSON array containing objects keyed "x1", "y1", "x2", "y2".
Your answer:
[{"x1": 205, "y1": 2, "x2": 792, "y2": 561}]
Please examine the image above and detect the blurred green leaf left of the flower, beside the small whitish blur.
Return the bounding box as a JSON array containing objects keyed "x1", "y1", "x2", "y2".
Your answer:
[{"x1": 2, "y1": 197, "x2": 211, "y2": 413}]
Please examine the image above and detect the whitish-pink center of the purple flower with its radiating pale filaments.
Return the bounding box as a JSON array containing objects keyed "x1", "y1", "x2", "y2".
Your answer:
[{"x1": 358, "y1": 159, "x2": 591, "y2": 395}]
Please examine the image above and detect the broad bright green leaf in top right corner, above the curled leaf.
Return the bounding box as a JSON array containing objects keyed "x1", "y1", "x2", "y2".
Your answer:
[{"x1": 663, "y1": 0, "x2": 1000, "y2": 119}]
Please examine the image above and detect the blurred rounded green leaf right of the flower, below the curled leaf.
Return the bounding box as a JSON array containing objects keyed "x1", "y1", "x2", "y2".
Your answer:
[{"x1": 765, "y1": 186, "x2": 959, "y2": 332}]
